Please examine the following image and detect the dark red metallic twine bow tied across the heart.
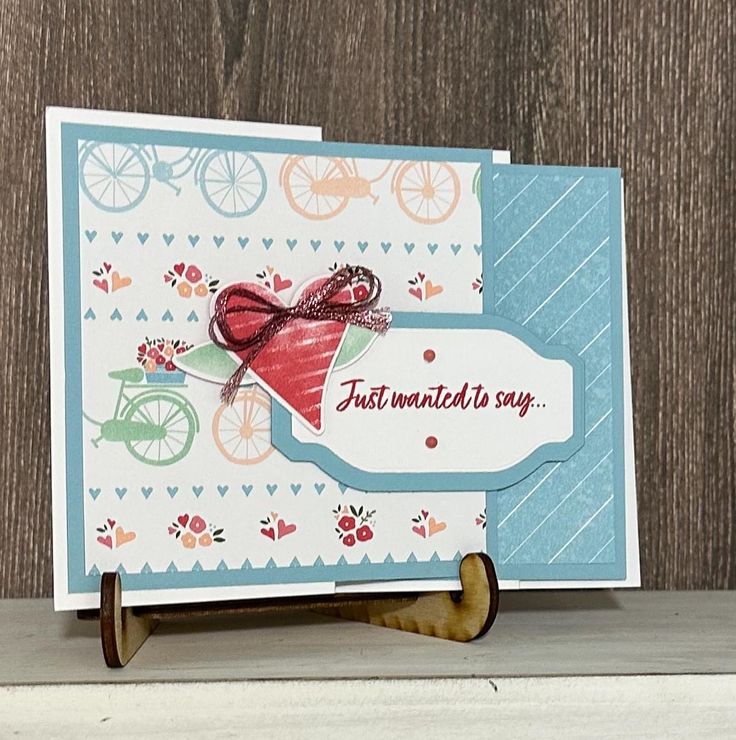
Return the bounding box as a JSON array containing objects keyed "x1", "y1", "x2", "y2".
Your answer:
[{"x1": 209, "y1": 266, "x2": 391, "y2": 404}]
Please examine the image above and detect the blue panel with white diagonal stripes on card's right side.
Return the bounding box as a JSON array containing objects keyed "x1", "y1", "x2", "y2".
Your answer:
[{"x1": 484, "y1": 165, "x2": 625, "y2": 579}]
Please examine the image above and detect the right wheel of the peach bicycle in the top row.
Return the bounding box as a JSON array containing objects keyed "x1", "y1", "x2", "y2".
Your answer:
[{"x1": 394, "y1": 162, "x2": 460, "y2": 224}]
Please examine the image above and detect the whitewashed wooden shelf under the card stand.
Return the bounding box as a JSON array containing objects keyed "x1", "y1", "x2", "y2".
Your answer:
[{"x1": 0, "y1": 592, "x2": 736, "y2": 740}]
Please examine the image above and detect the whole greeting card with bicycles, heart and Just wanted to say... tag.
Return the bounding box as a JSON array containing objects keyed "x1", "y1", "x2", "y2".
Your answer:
[{"x1": 47, "y1": 110, "x2": 631, "y2": 608}]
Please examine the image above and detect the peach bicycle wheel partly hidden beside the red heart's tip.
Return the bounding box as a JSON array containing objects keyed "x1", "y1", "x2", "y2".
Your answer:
[{"x1": 212, "y1": 387, "x2": 273, "y2": 465}]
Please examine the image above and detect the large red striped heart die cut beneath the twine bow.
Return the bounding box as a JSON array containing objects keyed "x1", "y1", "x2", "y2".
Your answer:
[{"x1": 221, "y1": 278, "x2": 350, "y2": 431}]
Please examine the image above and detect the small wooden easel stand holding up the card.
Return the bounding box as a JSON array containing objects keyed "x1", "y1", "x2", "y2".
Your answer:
[{"x1": 78, "y1": 553, "x2": 498, "y2": 668}]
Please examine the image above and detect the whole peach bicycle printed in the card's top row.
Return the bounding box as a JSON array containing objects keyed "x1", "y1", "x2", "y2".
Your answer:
[{"x1": 279, "y1": 155, "x2": 460, "y2": 224}]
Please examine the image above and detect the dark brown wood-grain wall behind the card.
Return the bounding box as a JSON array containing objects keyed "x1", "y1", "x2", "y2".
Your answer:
[{"x1": 0, "y1": 0, "x2": 736, "y2": 597}]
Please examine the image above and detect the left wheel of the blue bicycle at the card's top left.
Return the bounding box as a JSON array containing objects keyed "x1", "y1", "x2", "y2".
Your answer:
[{"x1": 79, "y1": 142, "x2": 151, "y2": 212}]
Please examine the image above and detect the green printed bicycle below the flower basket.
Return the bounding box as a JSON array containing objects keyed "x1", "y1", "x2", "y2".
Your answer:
[{"x1": 82, "y1": 367, "x2": 199, "y2": 465}]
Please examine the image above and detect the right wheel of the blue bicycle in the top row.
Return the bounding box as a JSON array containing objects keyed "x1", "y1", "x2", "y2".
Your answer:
[{"x1": 199, "y1": 151, "x2": 266, "y2": 218}]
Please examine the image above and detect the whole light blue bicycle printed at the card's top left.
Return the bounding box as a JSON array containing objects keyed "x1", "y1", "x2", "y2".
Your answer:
[{"x1": 79, "y1": 141, "x2": 266, "y2": 218}]
